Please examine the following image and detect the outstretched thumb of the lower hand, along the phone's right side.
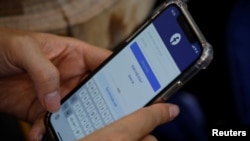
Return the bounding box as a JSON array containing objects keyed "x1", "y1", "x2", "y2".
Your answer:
[{"x1": 112, "y1": 103, "x2": 179, "y2": 140}]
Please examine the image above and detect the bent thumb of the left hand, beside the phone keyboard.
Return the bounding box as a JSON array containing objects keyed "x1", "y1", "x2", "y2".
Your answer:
[{"x1": 15, "y1": 35, "x2": 61, "y2": 112}]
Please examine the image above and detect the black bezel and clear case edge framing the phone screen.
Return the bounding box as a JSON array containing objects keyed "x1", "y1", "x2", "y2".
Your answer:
[{"x1": 44, "y1": 0, "x2": 213, "y2": 140}]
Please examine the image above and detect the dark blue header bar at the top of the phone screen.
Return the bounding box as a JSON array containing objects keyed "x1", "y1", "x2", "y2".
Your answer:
[{"x1": 153, "y1": 6, "x2": 201, "y2": 71}]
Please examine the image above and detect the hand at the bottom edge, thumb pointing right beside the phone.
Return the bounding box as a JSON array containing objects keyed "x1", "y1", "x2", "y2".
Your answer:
[{"x1": 80, "y1": 103, "x2": 179, "y2": 141}]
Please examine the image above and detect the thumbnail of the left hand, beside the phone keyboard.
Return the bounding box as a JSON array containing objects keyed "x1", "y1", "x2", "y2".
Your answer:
[{"x1": 44, "y1": 91, "x2": 61, "y2": 112}]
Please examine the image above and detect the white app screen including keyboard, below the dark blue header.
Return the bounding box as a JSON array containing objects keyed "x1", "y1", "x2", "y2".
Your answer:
[{"x1": 52, "y1": 24, "x2": 180, "y2": 141}]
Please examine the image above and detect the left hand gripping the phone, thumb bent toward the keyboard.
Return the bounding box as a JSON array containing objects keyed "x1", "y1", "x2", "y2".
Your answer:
[{"x1": 0, "y1": 28, "x2": 112, "y2": 140}]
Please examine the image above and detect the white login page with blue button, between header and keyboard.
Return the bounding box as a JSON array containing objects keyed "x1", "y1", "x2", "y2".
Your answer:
[{"x1": 94, "y1": 24, "x2": 180, "y2": 118}]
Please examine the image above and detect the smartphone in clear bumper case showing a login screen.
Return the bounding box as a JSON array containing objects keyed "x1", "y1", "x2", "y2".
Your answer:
[{"x1": 45, "y1": 0, "x2": 213, "y2": 141}]
